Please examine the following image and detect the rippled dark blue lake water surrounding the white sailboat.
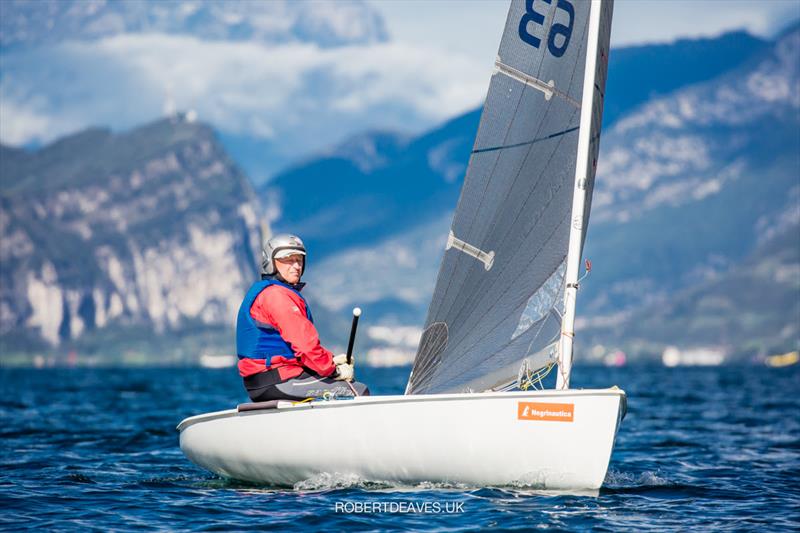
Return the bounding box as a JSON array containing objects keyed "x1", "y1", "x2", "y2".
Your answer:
[{"x1": 0, "y1": 366, "x2": 800, "y2": 531}]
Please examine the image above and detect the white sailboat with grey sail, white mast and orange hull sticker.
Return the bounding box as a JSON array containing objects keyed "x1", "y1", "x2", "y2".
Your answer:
[{"x1": 178, "y1": 0, "x2": 626, "y2": 489}]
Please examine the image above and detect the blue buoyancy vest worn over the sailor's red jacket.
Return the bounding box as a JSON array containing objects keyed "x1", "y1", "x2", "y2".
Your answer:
[{"x1": 236, "y1": 279, "x2": 314, "y2": 365}]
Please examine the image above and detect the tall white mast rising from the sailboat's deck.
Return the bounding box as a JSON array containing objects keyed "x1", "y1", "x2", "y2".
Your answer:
[{"x1": 556, "y1": 0, "x2": 604, "y2": 390}]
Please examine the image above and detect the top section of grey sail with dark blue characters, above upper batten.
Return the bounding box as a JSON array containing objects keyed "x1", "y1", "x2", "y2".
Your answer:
[{"x1": 497, "y1": 0, "x2": 590, "y2": 101}]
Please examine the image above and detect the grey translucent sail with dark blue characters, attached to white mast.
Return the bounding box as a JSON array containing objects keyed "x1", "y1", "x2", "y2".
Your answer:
[{"x1": 406, "y1": 0, "x2": 612, "y2": 394}]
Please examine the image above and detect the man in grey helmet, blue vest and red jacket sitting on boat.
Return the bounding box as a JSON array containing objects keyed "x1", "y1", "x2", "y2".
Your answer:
[{"x1": 236, "y1": 231, "x2": 369, "y2": 402}]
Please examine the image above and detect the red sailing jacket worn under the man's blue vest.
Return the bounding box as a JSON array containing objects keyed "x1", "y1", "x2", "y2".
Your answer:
[{"x1": 239, "y1": 285, "x2": 336, "y2": 381}]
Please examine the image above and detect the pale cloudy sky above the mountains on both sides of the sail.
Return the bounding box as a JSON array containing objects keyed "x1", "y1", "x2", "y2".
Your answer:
[{"x1": 0, "y1": 0, "x2": 800, "y2": 179}]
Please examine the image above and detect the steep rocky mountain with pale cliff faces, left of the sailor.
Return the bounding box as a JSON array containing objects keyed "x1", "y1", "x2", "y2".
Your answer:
[{"x1": 0, "y1": 116, "x2": 259, "y2": 363}]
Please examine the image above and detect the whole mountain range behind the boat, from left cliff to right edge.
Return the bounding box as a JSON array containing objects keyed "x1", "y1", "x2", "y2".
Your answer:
[{"x1": 0, "y1": 26, "x2": 800, "y2": 362}]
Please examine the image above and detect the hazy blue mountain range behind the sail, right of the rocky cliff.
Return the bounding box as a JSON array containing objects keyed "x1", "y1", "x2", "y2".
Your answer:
[{"x1": 268, "y1": 25, "x2": 800, "y2": 364}]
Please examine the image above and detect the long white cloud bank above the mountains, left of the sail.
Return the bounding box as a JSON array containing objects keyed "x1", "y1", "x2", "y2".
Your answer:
[{"x1": 0, "y1": 34, "x2": 490, "y2": 155}]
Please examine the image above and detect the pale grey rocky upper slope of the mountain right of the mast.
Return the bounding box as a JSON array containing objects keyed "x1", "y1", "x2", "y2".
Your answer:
[{"x1": 592, "y1": 29, "x2": 800, "y2": 222}]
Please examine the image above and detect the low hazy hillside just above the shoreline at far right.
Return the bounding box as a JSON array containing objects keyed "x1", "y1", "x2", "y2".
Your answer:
[{"x1": 581, "y1": 218, "x2": 800, "y2": 359}]
